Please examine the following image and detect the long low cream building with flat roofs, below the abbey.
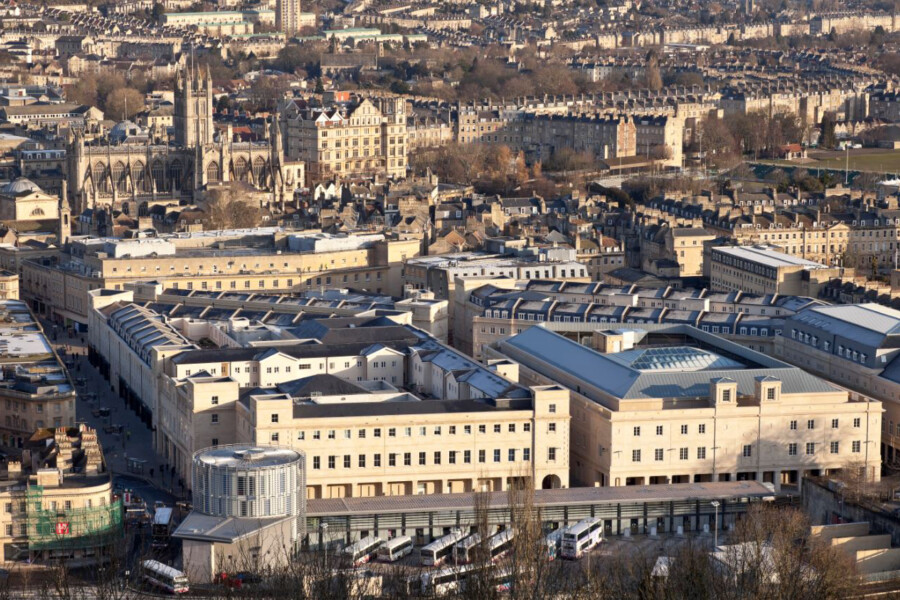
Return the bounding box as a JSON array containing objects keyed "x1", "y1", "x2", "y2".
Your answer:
[{"x1": 20, "y1": 228, "x2": 420, "y2": 324}]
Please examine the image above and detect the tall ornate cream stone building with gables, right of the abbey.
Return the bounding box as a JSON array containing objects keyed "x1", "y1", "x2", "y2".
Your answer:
[{"x1": 282, "y1": 97, "x2": 408, "y2": 184}]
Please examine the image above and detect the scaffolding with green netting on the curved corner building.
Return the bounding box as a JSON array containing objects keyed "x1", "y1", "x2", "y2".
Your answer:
[{"x1": 26, "y1": 485, "x2": 124, "y2": 552}]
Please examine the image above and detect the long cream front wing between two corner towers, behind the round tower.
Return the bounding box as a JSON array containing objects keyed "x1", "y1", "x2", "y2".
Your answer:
[{"x1": 195, "y1": 375, "x2": 569, "y2": 498}]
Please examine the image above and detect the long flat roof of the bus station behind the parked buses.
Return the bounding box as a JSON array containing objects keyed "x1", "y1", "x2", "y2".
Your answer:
[{"x1": 306, "y1": 481, "x2": 773, "y2": 517}]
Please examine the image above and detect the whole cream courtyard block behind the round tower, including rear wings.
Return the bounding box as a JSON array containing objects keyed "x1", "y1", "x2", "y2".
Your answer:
[{"x1": 149, "y1": 318, "x2": 569, "y2": 497}]
